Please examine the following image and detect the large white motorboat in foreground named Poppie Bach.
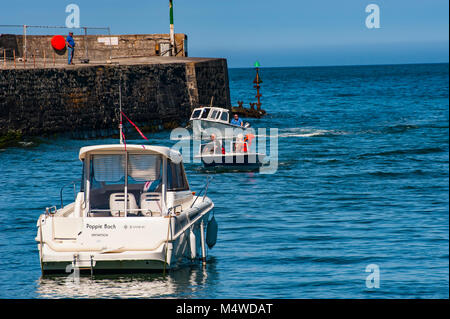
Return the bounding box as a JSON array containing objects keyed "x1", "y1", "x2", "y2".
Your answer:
[{"x1": 36, "y1": 144, "x2": 217, "y2": 274}]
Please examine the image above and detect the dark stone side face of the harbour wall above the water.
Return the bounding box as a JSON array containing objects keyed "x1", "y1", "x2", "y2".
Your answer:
[{"x1": 0, "y1": 58, "x2": 231, "y2": 142}]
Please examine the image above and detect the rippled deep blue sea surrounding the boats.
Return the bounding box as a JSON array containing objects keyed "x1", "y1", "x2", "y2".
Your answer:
[{"x1": 0, "y1": 64, "x2": 449, "y2": 298}]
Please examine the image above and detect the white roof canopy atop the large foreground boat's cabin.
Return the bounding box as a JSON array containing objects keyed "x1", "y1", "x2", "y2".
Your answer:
[{"x1": 78, "y1": 144, "x2": 182, "y2": 163}]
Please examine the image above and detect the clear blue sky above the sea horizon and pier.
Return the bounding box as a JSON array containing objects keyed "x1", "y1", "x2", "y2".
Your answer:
[{"x1": 0, "y1": 0, "x2": 449, "y2": 67}]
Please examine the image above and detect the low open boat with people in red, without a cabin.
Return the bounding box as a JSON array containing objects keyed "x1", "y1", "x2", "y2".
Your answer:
[{"x1": 194, "y1": 134, "x2": 266, "y2": 170}]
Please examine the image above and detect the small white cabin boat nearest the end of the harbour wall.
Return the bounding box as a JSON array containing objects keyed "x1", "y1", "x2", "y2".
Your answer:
[{"x1": 190, "y1": 107, "x2": 250, "y2": 139}]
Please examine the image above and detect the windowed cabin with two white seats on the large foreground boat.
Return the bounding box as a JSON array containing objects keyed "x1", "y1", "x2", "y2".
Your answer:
[{"x1": 75, "y1": 144, "x2": 193, "y2": 217}]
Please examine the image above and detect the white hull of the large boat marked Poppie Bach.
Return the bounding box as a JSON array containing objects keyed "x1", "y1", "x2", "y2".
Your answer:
[{"x1": 36, "y1": 200, "x2": 214, "y2": 274}]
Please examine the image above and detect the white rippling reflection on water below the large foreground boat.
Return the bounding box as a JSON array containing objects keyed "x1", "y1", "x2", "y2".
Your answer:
[{"x1": 36, "y1": 258, "x2": 217, "y2": 298}]
